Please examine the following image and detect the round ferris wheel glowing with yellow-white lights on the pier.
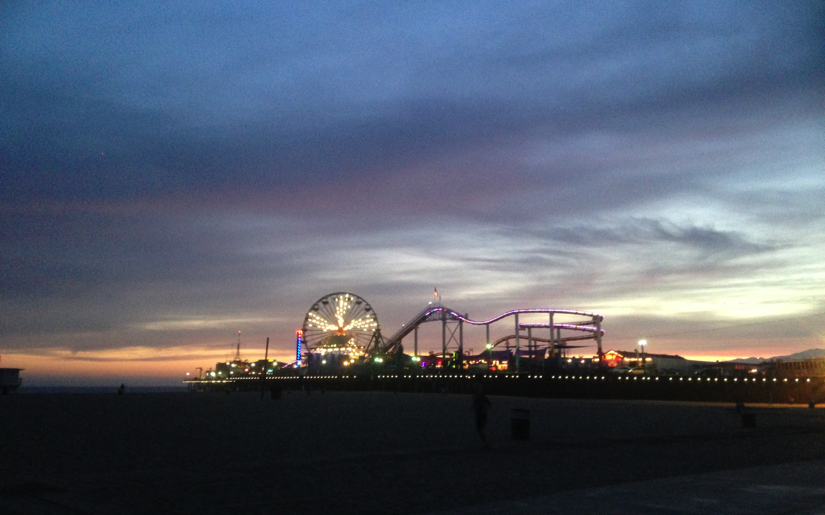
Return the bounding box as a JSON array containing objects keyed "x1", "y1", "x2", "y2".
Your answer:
[{"x1": 302, "y1": 292, "x2": 378, "y2": 354}]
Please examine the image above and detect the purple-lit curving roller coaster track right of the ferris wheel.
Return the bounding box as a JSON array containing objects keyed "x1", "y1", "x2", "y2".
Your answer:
[{"x1": 380, "y1": 306, "x2": 604, "y2": 353}]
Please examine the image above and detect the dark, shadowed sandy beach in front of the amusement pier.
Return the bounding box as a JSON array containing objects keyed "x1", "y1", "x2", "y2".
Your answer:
[{"x1": 0, "y1": 391, "x2": 825, "y2": 514}]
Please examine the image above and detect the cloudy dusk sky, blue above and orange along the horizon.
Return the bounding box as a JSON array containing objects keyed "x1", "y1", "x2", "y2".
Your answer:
[{"x1": 0, "y1": 0, "x2": 825, "y2": 384}]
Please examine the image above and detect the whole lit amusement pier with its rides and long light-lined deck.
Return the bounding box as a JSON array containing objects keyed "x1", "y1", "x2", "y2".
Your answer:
[{"x1": 184, "y1": 292, "x2": 825, "y2": 407}]
